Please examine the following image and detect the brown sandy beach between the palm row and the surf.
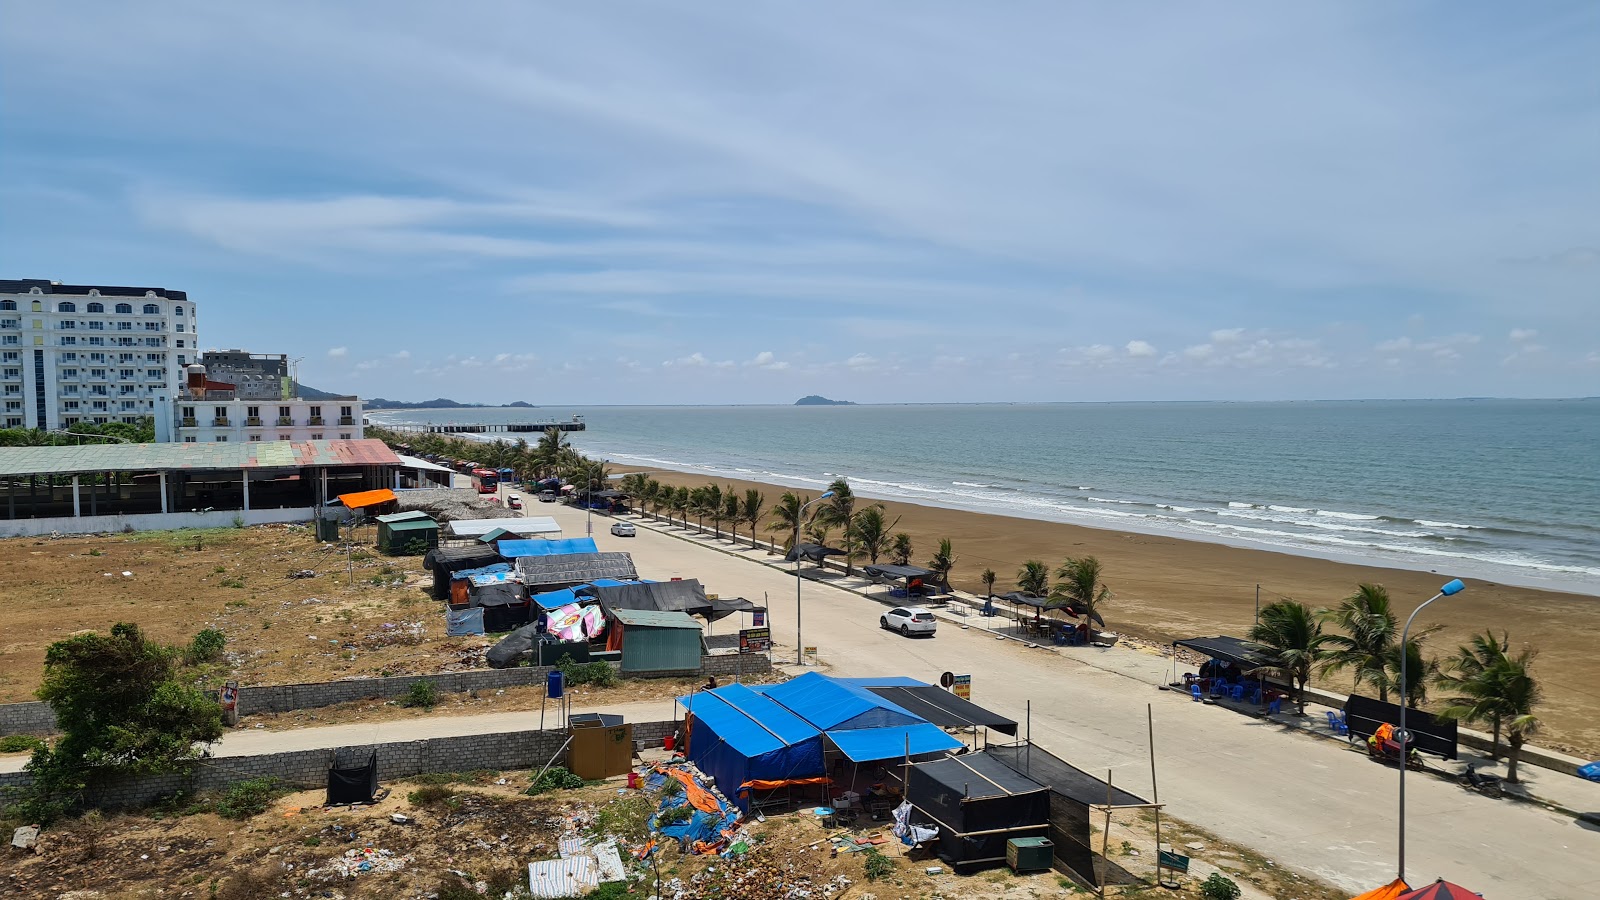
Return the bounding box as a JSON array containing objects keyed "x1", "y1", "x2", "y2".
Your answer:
[{"x1": 630, "y1": 469, "x2": 1600, "y2": 759}]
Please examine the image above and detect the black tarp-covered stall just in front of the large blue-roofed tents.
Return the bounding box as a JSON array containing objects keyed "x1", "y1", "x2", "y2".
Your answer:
[{"x1": 906, "y1": 753, "x2": 1050, "y2": 873}]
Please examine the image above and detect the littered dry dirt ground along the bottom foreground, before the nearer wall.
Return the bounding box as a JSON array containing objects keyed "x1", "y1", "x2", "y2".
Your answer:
[{"x1": 0, "y1": 755, "x2": 1344, "y2": 900}]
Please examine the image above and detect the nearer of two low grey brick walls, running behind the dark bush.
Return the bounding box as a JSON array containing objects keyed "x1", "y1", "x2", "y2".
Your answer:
[{"x1": 0, "y1": 721, "x2": 678, "y2": 809}]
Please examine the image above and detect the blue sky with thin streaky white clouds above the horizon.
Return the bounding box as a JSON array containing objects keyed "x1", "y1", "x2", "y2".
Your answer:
[{"x1": 0, "y1": 0, "x2": 1600, "y2": 398}]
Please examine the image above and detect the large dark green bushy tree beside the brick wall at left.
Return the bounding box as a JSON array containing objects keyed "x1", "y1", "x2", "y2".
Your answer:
[{"x1": 27, "y1": 623, "x2": 222, "y2": 804}]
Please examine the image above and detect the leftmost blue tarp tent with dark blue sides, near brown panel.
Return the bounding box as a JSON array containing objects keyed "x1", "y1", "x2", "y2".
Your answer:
[{"x1": 678, "y1": 684, "x2": 824, "y2": 810}]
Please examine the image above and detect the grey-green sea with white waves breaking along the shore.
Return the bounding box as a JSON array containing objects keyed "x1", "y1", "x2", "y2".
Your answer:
[{"x1": 368, "y1": 399, "x2": 1600, "y2": 596}]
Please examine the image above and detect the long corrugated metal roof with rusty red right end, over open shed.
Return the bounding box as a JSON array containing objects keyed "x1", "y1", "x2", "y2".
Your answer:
[{"x1": 0, "y1": 440, "x2": 400, "y2": 476}]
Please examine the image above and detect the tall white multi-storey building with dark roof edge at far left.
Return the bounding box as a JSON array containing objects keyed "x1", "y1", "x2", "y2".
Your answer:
[{"x1": 0, "y1": 279, "x2": 200, "y2": 429}]
